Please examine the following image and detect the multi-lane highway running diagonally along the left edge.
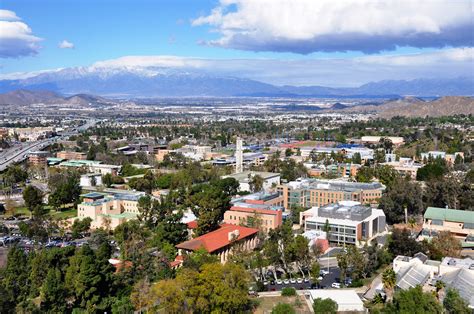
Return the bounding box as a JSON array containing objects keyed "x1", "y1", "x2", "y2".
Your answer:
[{"x1": 0, "y1": 119, "x2": 97, "y2": 172}]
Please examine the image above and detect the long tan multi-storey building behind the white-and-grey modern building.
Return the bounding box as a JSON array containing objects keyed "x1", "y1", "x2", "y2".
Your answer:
[{"x1": 278, "y1": 179, "x2": 385, "y2": 209}]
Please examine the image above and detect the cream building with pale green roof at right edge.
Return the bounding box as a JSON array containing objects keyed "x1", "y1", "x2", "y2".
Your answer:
[{"x1": 421, "y1": 207, "x2": 474, "y2": 240}]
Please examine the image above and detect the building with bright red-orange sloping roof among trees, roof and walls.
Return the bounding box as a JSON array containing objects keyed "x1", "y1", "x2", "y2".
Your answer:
[{"x1": 176, "y1": 224, "x2": 258, "y2": 263}]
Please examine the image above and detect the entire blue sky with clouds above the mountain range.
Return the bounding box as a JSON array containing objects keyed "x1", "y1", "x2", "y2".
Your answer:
[{"x1": 0, "y1": 0, "x2": 474, "y2": 86}]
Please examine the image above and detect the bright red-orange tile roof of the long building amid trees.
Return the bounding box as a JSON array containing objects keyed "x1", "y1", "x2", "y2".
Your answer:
[{"x1": 176, "y1": 224, "x2": 258, "y2": 253}]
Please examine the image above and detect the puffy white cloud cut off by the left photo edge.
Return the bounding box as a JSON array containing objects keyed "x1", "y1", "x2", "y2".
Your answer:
[{"x1": 0, "y1": 10, "x2": 42, "y2": 58}]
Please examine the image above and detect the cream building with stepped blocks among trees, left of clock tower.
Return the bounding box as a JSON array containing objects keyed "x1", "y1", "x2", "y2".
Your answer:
[{"x1": 71, "y1": 189, "x2": 145, "y2": 230}]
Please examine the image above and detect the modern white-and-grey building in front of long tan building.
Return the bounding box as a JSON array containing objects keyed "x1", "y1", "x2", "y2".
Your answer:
[{"x1": 300, "y1": 201, "x2": 386, "y2": 246}]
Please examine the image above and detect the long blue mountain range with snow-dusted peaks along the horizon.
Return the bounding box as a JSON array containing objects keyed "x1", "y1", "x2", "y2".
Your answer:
[{"x1": 0, "y1": 66, "x2": 474, "y2": 98}]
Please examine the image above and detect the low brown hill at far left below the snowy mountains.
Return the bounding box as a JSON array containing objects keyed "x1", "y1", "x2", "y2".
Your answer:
[{"x1": 0, "y1": 90, "x2": 111, "y2": 106}]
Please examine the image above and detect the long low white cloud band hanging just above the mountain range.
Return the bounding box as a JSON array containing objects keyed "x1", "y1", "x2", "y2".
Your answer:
[{"x1": 0, "y1": 48, "x2": 474, "y2": 87}]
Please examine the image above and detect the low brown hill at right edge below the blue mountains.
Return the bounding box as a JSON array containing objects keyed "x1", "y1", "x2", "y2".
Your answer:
[{"x1": 344, "y1": 96, "x2": 474, "y2": 118}]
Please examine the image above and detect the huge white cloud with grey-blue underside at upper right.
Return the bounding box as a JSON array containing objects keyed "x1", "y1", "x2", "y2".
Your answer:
[{"x1": 192, "y1": 0, "x2": 474, "y2": 53}]
